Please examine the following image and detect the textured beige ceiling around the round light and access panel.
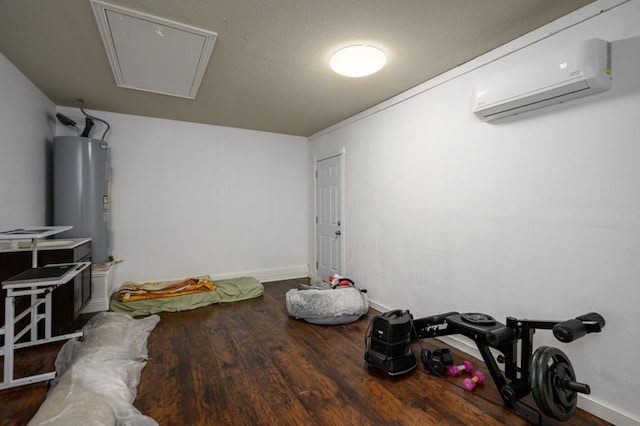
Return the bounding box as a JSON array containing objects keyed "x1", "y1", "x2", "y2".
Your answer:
[{"x1": 0, "y1": 0, "x2": 593, "y2": 136}]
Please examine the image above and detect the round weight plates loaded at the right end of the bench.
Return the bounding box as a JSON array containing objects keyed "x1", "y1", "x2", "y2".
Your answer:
[{"x1": 529, "y1": 346, "x2": 578, "y2": 421}]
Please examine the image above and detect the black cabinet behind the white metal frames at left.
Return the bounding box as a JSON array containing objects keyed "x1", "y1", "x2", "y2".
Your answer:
[{"x1": 0, "y1": 239, "x2": 91, "y2": 336}]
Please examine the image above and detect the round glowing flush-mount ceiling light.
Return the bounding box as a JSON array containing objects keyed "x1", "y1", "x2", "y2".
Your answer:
[{"x1": 329, "y1": 45, "x2": 387, "y2": 77}]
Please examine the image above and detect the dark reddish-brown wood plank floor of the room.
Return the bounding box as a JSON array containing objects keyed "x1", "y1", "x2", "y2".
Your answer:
[{"x1": 0, "y1": 280, "x2": 608, "y2": 425}]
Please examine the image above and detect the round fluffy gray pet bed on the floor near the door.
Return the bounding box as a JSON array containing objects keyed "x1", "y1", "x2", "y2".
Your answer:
[{"x1": 286, "y1": 284, "x2": 369, "y2": 325}]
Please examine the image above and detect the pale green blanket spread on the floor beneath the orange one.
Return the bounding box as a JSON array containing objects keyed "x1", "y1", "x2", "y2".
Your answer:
[{"x1": 109, "y1": 277, "x2": 264, "y2": 317}]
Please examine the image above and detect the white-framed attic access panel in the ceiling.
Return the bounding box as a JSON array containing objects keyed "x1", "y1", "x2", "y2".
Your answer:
[{"x1": 91, "y1": 0, "x2": 217, "y2": 99}]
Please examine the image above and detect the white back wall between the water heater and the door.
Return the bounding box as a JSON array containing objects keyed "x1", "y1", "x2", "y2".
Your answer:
[{"x1": 57, "y1": 107, "x2": 308, "y2": 285}]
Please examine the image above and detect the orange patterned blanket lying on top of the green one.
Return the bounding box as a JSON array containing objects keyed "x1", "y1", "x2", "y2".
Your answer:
[{"x1": 118, "y1": 276, "x2": 216, "y2": 302}]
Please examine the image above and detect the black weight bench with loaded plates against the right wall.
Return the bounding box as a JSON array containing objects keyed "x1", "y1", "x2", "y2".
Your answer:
[{"x1": 413, "y1": 312, "x2": 605, "y2": 424}]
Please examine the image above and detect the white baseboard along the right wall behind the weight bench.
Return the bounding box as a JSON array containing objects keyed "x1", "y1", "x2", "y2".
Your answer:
[{"x1": 369, "y1": 300, "x2": 640, "y2": 426}]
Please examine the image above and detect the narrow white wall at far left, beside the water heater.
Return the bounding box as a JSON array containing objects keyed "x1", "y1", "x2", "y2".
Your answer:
[{"x1": 0, "y1": 53, "x2": 56, "y2": 230}]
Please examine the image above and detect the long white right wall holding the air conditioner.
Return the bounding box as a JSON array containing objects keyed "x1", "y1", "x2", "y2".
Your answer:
[{"x1": 309, "y1": 1, "x2": 640, "y2": 424}]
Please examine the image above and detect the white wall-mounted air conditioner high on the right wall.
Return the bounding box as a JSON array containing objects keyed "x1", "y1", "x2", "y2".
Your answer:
[{"x1": 473, "y1": 39, "x2": 611, "y2": 121}]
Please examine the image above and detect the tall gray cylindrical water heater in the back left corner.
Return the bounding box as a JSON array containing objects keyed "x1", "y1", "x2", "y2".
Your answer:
[{"x1": 53, "y1": 136, "x2": 111, "y2": 263}]
